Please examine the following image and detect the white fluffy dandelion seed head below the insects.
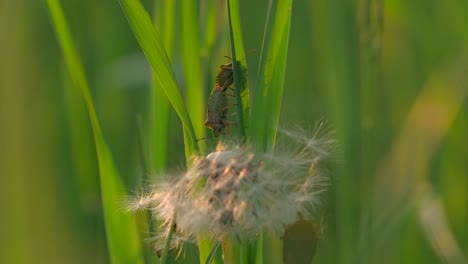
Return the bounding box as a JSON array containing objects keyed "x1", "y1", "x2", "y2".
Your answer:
[{"x1": 130, "y1": 123, "x2": 335, "y2": 248}]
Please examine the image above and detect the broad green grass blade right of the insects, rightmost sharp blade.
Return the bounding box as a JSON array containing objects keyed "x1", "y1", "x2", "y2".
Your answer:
[{"x1": 249, "y1": 0, "x2": 292, "y2": 155}]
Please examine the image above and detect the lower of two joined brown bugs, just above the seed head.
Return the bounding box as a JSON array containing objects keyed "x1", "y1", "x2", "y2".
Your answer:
[{"x1": 205, "y1": 85, "x2": 237, "y2": 137}]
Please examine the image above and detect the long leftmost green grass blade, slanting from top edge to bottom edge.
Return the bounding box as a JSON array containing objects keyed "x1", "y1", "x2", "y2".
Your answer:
[{"x1": 47, "y1": 0, "x2": 143, "y2": 263}]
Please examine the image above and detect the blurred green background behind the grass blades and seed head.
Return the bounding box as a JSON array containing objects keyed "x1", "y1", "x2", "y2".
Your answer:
[{"x1": 0, "y1": 0, "x2": 468, "y2": 263}]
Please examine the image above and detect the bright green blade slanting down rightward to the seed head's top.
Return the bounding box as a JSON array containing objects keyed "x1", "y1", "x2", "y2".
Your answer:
[{"x1": 118, "y1": 0, "x2": 198, "y2": 159}]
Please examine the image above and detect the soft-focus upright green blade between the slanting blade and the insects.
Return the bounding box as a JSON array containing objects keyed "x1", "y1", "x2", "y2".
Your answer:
[{"x1": 181, "y1": 1, "x2": 209, "y2": 154}]
